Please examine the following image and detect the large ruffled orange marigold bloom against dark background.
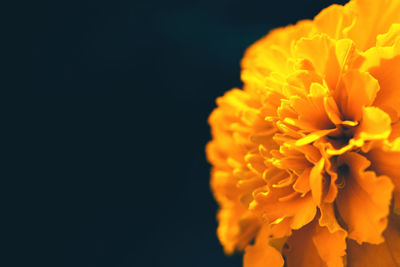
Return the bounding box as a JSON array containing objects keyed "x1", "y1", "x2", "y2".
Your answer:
[{"x1": 206, "y1": 0, "x2": 400, "y2": 267}]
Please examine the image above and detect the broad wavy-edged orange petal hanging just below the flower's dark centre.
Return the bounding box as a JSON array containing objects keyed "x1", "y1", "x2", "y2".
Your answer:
[{"x1": 336, "y1": 152, "x2": 393, "y2": 244}]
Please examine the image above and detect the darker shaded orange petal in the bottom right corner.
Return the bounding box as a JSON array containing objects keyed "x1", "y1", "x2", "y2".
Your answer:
[{"x1": 347, "y1": 215, "x2": 400, "y2": 267}]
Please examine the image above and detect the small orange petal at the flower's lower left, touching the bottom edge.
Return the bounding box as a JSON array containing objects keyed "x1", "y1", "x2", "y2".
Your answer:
[{"x1": 243, "y1": 225, "x2": 284, "y2": 267}]
